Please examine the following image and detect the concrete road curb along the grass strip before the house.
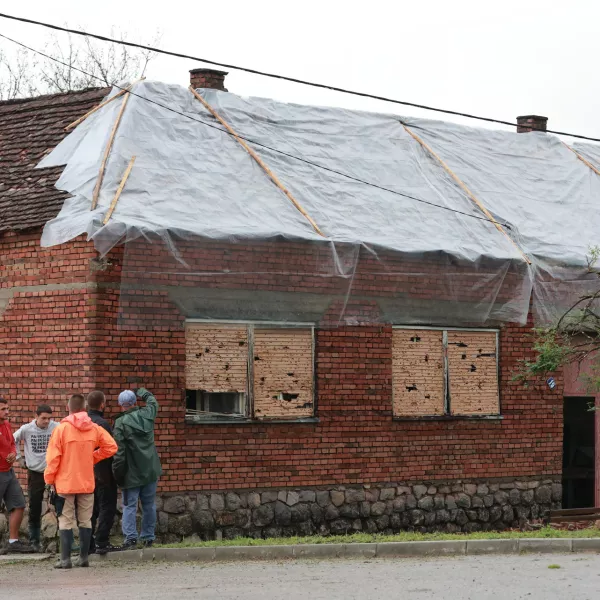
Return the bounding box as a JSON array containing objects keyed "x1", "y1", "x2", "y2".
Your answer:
[{"x1": 90, "y1": 538, "x2": 600, "y2": 563}]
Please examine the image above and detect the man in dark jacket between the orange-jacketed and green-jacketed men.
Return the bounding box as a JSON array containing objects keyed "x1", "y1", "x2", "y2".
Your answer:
[{"x1": 87, "y1": 390, "x2": 121, "y2": 554}]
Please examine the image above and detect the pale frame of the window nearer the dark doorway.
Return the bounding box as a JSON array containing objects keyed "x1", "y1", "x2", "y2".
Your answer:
[{"x1": 392, "y1": 325, "x2": 504, "y2": 421}]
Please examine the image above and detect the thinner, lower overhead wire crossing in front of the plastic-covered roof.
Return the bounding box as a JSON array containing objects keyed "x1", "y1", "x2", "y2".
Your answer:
[{"x1": 0, "y1": 33, "x2": 511, "y2": 229}]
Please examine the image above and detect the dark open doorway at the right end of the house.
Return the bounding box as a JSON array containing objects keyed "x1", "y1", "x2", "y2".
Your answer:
[{"x1": 563, "y1": 397, "x2": 596, "y2": 508}]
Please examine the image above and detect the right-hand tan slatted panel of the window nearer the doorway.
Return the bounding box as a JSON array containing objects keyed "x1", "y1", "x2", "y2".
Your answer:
[{"x1": 448, "y1": 331, "x2": 499, "y2": 415}]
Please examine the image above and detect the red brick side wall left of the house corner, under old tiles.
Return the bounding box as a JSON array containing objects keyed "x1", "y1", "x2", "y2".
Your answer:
[{"x1": 0, "y1": 234, "x2": 95, "y2": 412}]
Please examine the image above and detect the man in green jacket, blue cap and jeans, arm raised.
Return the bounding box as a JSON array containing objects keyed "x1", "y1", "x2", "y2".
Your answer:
[{"x1": 113, "y1": 388, "x2": 162, "y2": 549}]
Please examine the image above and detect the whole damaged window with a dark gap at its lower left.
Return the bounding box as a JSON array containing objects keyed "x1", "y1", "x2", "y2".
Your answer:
[{"x1": 186, "y1": 321, "x2": 314, "y2": 421}]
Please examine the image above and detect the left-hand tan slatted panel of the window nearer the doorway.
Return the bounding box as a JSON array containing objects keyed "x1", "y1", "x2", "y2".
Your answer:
[{"x1": 392, "y1": 329, "x2": 444, "y2": 416}]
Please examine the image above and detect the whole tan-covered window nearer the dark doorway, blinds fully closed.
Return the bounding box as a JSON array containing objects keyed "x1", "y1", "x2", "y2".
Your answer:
[{"x1": 392, "y1": 328, "x2": 500, "y2": 417}]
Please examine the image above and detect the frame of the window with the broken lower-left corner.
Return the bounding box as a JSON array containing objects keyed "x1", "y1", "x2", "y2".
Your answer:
[{"x1": 183, "y1": 318, "x2": 319, "y2": 425}]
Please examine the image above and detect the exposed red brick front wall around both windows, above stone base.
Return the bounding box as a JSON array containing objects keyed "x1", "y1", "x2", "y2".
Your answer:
[{"x1": 96, "y1": 288, "x2": 562, "y2": 492}]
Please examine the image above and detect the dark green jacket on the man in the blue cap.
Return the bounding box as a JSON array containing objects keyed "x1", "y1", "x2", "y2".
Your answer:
[{"x1": 113, "y1": 388, "x2": 162, "y2": 489}]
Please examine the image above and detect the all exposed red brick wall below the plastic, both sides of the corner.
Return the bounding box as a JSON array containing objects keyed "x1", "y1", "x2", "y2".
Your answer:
[{"x1": 0, "y1": 232, "x2": 562, "y2": 492}]
